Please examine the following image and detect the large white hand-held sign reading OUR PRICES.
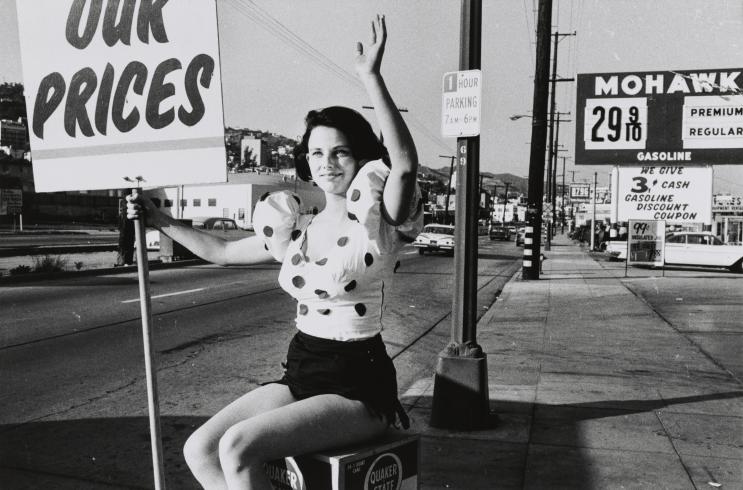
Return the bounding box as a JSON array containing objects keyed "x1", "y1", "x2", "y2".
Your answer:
[{"x1": 16, "y1": 0, "x2": 227, "y2": 192}]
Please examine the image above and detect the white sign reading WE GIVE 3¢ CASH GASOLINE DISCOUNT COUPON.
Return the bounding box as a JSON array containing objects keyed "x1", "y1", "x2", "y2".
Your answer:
[{"x1": 617, "y1": 165, "x2": 712, "y2": 223}]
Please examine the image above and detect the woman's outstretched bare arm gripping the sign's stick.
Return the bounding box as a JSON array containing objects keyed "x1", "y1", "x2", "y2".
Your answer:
[{"x1": 126, "y1": 194, "x2": 275, "y2": 265}]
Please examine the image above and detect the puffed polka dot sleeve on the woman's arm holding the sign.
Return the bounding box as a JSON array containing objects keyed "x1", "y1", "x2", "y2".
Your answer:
[{"x1": 253, "y1": 191, "x2": 301, "y2": 262}]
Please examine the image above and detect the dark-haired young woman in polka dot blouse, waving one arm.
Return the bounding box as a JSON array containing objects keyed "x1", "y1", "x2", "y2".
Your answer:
[{"x1": 129, "y1": 16, "x2": 422, "y2": 489}]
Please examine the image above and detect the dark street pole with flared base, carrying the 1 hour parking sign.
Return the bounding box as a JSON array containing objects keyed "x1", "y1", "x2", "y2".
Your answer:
[{"x1": 430, "y1": 0, "x2": 492, "y2": 430}]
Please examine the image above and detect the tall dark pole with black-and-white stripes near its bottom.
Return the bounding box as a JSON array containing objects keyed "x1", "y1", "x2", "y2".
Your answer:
[{"x1": 521, "y1": 0, "x2": 552, "y2": 280}]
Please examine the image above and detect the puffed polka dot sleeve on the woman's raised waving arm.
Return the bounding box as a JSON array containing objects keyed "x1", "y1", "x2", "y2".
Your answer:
[{"x1": 346, "y1": 160, "x2": 423, "y2": 253}]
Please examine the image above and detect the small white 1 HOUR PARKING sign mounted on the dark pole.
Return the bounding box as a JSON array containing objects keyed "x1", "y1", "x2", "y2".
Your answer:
[{"x1": 441, "y1": 70, "x2": 482, "y2": 138}]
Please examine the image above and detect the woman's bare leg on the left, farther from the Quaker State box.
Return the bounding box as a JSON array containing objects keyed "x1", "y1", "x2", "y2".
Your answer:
[{"x1": 183, "y1": 384, "x2": 296, "y2": 490}]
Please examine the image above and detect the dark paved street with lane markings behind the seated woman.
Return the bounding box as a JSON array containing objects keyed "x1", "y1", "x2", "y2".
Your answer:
[{"x1": 0, "y1": 239, "x2": 521, "y2": 488}]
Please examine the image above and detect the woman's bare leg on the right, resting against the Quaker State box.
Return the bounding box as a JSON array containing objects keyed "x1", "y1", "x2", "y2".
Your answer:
[{"x1": 219, "y1": 395, "x2": 388, "y2": 490}]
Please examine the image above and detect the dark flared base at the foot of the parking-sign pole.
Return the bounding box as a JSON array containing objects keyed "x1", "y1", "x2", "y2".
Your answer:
[{"x1": 429, "y1": 352, "x2": 497, "y2": 430}]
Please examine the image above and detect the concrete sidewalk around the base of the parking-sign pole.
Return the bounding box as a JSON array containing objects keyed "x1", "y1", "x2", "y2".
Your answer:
[{"x1": 402, "y1": 237, "x2": 743, "y2": 490}]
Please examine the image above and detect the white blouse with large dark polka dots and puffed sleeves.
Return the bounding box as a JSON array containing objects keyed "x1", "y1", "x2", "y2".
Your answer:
[{"x1": 253, "y1": 160, "x2": 423, "y2": 340}]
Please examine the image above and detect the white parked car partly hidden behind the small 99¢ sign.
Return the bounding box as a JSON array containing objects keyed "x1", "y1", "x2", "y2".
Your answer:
[{"x1": 606, "y1": 231, "x2": 743, "y2": 272}]
